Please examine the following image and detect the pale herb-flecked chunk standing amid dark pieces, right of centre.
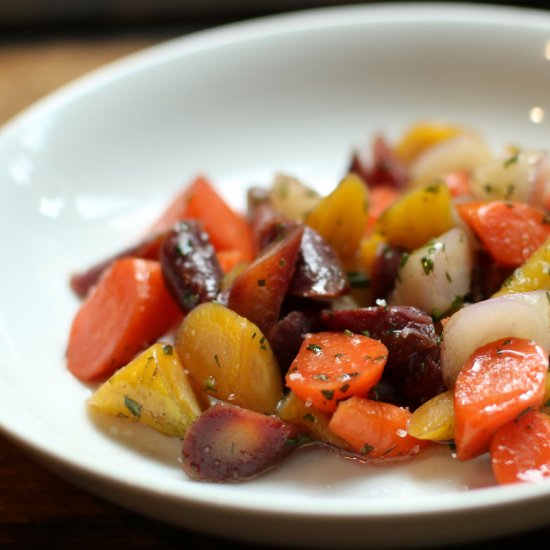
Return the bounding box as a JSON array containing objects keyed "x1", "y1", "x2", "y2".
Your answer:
[{"x1": 389, "y1": 228, "x2": 473, "y2": 317}]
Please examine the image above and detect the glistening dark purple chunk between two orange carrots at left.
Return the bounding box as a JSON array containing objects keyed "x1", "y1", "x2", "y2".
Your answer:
[{"x1": 160, "y1": 220, "x2": 223, "y2": 313}]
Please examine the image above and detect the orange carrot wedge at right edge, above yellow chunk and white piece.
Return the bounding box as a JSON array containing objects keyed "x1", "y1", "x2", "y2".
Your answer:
[{"x1": 456, "y1": 200, "x2": 550, "y2": 267}]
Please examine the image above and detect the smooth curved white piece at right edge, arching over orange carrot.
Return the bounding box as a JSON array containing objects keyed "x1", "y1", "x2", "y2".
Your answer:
[{"x1": 441, "y1": 290, "x2": 550, "y2": 388}]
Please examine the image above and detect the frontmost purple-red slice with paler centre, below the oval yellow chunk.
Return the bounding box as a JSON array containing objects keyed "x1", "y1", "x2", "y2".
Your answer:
[{"x1": 182, "y1": 403, "x2": 303, "y2": 482}]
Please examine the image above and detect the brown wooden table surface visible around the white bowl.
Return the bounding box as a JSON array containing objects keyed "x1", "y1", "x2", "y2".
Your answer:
[{"x1": 0, "y1": 25, "x2": 550, "y2": 550}]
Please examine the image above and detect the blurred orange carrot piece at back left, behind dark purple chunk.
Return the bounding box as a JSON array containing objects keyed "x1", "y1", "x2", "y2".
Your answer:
[{"x1": 150, "y1": 176, "x2": 254, "y2": 261}]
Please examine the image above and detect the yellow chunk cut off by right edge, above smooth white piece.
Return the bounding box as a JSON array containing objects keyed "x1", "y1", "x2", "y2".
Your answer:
[{"x1": 493, "y1": 237, "x2": 550, "y2": 296}]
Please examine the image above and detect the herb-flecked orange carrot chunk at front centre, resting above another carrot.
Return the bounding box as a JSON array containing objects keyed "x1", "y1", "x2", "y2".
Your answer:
[{"x1": 286, "y1": 332, "x2": 388, "y2": 413}]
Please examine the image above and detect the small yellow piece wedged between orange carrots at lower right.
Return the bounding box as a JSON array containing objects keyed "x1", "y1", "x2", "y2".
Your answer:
[{"x1": 408, "y1": 390, "x2": 455, "y2": 441}]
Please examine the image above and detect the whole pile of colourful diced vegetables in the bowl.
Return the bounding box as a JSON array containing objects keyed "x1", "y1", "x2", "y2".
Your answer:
[{"x1": 67, "y1": 121, "x2": 550, "y2": 483}]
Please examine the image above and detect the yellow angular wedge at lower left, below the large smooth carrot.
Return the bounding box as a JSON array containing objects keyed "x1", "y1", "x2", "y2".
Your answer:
[{"x1": 88, "y1": 343, "x2": 202, "y2": 438}]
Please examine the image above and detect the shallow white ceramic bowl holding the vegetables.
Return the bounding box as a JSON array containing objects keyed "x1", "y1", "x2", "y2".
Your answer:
[{"x1": 0, "y1": 4, "x2": 550, "y2": 548}]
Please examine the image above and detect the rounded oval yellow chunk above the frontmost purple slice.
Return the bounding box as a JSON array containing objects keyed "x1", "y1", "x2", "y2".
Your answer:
[{"x1": 176, "y1": 302, "x2": 282, "y2": 414}]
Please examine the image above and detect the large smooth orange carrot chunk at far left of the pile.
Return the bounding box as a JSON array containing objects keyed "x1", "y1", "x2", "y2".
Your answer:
[{"x1": 67, "y1": 258, "x2": 180, "y2": 380}]
